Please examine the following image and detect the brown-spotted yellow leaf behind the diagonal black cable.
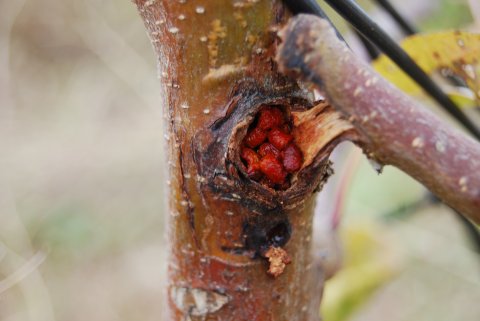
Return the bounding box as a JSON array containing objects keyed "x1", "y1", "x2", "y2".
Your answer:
[{"x1": 373, "y1": 31, "x2": 480, "y2": 107}]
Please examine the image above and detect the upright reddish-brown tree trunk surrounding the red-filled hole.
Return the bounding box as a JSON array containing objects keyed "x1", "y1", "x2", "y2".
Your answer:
[{"x1": 131, "y1": 0, "x2": 348, "y2": 321}]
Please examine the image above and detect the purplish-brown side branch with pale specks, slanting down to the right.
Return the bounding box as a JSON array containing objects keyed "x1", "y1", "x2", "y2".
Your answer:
[{"x1": 276, "y1": 15, "x2": 480, "y2": 223}]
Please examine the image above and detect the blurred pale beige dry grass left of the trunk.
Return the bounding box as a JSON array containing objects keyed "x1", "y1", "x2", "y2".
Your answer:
[{"x1": 0, "y1": 0, "x2": 168, "y2": 321}]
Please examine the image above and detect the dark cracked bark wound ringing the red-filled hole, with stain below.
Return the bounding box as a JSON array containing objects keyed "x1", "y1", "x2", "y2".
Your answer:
[{"x1": 193, "y1": 81, "x2": 355, "y2": 277}]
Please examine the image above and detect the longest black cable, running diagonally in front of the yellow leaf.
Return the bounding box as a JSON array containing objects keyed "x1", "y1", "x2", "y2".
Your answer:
[{"x1": 325, "y1": 0, "x2": 480, "y2": 140}]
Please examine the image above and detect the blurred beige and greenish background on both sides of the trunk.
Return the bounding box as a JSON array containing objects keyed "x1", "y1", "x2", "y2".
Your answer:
[{"x1": 0, "y1": 0, "x2": 480, "y2": 321}]
